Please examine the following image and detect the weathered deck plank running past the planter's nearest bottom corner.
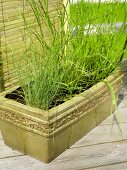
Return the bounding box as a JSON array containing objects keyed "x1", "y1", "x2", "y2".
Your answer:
[{"x1": 0, "y1": 141, "x2": 127, "y2": 170}]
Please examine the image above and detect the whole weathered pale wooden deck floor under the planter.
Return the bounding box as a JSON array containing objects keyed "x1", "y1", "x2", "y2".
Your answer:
[{"x1": 0, "y1": 89, "x2": 127, "y2": 170}]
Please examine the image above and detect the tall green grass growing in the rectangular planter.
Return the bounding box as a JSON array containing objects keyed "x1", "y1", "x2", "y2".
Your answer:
[{"x1": 13, "y1": 0, "x2": 126, "y2": 110}]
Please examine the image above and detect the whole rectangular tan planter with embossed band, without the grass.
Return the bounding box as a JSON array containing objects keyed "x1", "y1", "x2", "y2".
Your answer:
[{"x1": 0, "y1": 73, "x2": 122, "y2": 162}]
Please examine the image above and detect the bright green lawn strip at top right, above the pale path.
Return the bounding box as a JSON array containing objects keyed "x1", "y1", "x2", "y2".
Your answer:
[{"x1": 70, "y1": 2, "x2": 127, "y2": 24}]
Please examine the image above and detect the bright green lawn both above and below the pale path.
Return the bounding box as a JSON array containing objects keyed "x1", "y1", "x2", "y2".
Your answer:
[{"x1": 70, "y1": 2, "x2": 127, "y2": 56}]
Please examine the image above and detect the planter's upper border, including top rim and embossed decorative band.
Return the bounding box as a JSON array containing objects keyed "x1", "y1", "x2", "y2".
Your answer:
[{"x1": 0, "y1": 72, "x2": 123, "y2": 137}]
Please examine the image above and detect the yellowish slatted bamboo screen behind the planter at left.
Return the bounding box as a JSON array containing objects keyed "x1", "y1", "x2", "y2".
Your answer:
[{"x1": 0, "y1": 0, "x2": 63, "y2": 89}]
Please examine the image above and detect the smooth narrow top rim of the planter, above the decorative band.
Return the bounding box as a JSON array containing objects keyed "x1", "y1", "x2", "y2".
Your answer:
[{"x1": 0, "y1": 71, "x2": 123, "y2": 120}]
